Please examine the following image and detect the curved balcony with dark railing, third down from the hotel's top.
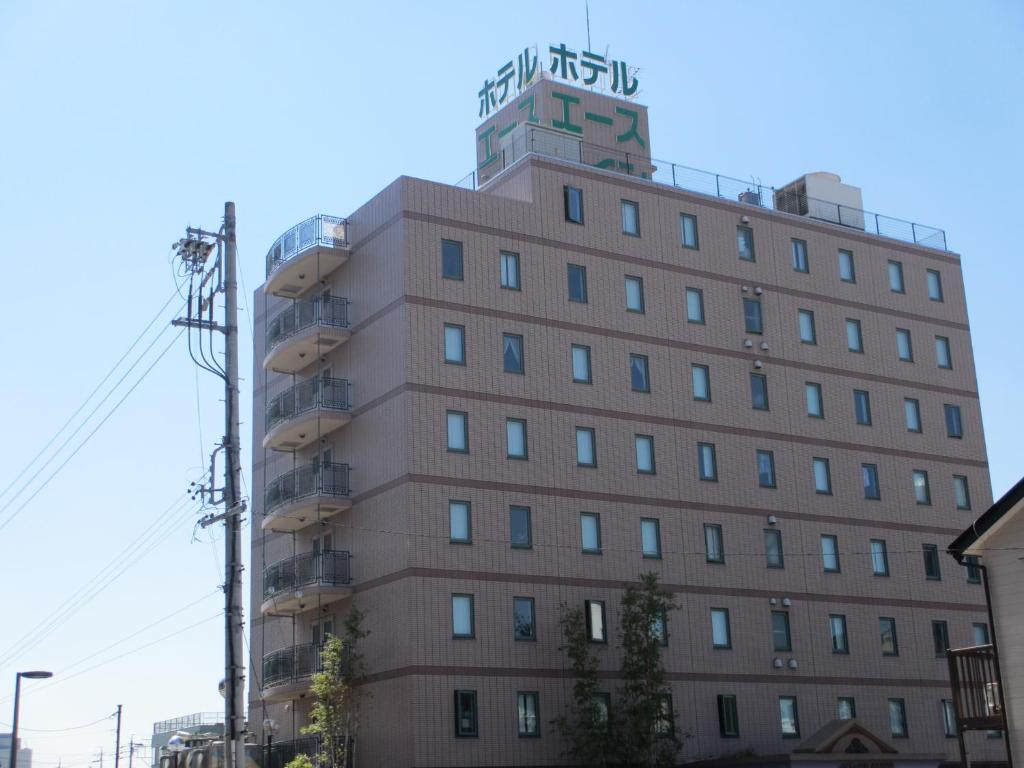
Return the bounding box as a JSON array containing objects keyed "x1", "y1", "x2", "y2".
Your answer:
[{"x1": 263, "y1": 376, "x2": 352, "y2": 451}]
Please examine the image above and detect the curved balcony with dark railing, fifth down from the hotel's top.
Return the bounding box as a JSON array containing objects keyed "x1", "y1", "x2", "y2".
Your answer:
[{"x1": 260, "y1": 550, "x2": 352, "y2": 614}]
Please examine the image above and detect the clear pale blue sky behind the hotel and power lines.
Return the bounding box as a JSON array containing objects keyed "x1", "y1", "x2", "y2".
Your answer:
[{"x1": 0, "y1": 0, "x2": 1024, "y2": 768}]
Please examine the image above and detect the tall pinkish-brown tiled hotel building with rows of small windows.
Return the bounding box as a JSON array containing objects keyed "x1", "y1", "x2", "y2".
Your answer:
[{"x1": 249, "y1": 70, "x2": 1002, "y2": 768}]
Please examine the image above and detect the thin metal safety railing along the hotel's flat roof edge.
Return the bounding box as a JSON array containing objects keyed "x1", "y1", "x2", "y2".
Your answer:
[{"x1": 456, "y1": 127, "x2": 948, "y2": 251}]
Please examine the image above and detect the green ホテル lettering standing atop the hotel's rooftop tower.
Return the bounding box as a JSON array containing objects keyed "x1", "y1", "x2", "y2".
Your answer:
[{"x1": 476, "y1": 43, "x2": 639, "y2": 118}]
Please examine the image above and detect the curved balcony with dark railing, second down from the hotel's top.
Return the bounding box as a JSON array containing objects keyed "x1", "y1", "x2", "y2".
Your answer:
[{"x1": 263, "y1": 296, "x2": 352, "y2": 374}]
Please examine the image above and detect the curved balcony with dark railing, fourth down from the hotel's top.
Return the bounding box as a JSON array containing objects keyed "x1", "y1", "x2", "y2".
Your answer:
[{"x1": 261, "y1": 462, "x2": 352, "y2": 531}]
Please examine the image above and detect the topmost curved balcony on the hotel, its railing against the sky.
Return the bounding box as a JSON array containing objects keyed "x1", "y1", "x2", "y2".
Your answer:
[{"x1": 263, "y1": 214, "x2": 350, "y2": 299}]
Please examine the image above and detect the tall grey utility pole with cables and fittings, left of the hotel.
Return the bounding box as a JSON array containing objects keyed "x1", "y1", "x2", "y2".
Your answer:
[{"x1": 172, "y1": 202, "x2": 246, "y2": 768}]
